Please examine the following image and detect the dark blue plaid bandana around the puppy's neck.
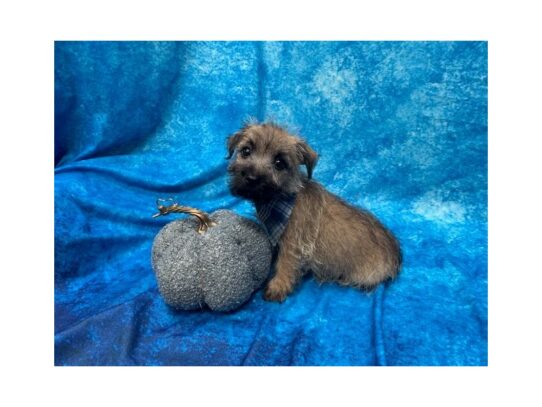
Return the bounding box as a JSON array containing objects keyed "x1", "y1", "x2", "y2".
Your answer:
[{"x1": 256, "y1": 195, "x2": 295, "y2": 247}]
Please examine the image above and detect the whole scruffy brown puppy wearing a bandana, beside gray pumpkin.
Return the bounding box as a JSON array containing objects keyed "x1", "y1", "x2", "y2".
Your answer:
[{"x1": 227, "y1": 123, "x2": 401, "y2": 301}]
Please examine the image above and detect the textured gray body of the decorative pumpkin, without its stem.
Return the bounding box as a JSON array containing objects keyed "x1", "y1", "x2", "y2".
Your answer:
[{"x1": 152, "y1": 210, "x2": 272, "y2": 311}]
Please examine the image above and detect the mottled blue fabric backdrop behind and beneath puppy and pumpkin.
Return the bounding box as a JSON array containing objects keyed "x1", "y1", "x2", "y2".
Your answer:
[{"x1": 55, "y1": 42, "x2": 487, "y2": 365}]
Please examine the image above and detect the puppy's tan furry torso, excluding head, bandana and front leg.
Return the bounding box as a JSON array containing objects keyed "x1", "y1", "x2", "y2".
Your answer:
[{"x1": 292, "y1": 180, "x2": 401, "y2": 289}]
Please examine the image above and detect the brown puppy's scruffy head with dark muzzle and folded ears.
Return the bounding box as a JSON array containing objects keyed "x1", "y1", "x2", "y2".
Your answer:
[{"x1": 227, "y1": 123, "x2": 318, "y2": 202}]
